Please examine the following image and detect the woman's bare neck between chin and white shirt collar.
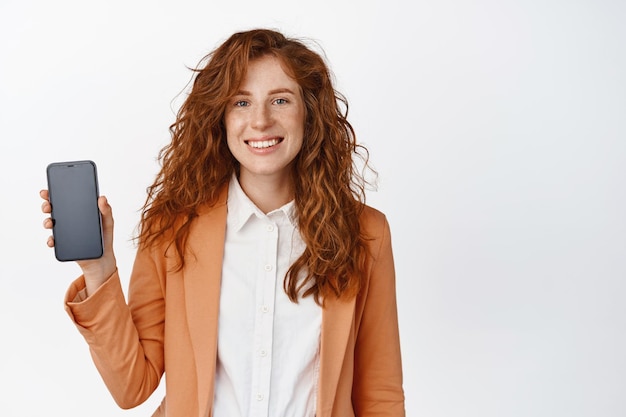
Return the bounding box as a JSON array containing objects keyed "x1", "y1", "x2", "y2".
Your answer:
[{"x1": 239, "y1": 172, "x2": 294, "y2": 214}]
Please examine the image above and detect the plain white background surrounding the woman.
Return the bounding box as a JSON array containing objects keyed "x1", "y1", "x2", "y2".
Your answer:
[{"x1": 0, "y1": 0, "x2": 626, "y2": 417}]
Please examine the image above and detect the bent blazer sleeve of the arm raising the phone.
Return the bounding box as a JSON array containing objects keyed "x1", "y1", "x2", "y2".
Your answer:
[{"x1": 65, "y1": 242, "x2": 165, "y2": 409}]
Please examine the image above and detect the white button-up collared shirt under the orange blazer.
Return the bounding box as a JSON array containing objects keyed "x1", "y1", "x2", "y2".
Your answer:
[{"x1": 213, "y1": 176, "x2": 322, "y2": 417}]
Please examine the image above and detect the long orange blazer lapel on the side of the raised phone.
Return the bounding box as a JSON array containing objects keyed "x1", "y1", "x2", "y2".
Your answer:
[{"x1": 183, "y1": 187, "x2": 228, "y2": 415}]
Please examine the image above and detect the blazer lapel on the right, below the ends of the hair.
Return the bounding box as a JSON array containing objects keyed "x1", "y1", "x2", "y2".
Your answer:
[{"x1": 317, "y1": 299, "x2": 356, "y2": 416}]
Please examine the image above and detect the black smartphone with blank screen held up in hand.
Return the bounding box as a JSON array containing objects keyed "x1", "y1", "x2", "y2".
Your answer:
[{"x1": 46, "y1": 161, "x2": 103, "y2": 262}]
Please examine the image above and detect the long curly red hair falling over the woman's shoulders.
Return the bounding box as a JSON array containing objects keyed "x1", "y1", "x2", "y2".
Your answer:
[{"x1": 139, "y1": 29, "x2": 368, "y2": 304}]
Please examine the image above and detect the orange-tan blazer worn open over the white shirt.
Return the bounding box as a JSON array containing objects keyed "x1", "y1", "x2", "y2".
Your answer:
[{"x1": 66, "y1": 186, "x2": 405, "y2": 417}]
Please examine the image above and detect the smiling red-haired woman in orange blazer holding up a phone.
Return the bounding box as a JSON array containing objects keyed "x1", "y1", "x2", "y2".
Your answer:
[{"x1": 41, "y1": 30, "x2": 405, "y2": 417}]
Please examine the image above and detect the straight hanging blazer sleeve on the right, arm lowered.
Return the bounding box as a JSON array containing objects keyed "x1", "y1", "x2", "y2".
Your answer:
[{"x1": 352, "y1": 212, "x2": 405, "y2": 417}]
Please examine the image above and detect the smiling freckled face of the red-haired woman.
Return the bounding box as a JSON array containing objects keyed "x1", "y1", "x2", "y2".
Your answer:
[{"x1": 224, "y1": 55, "x2": 305, "y2": 190}]
